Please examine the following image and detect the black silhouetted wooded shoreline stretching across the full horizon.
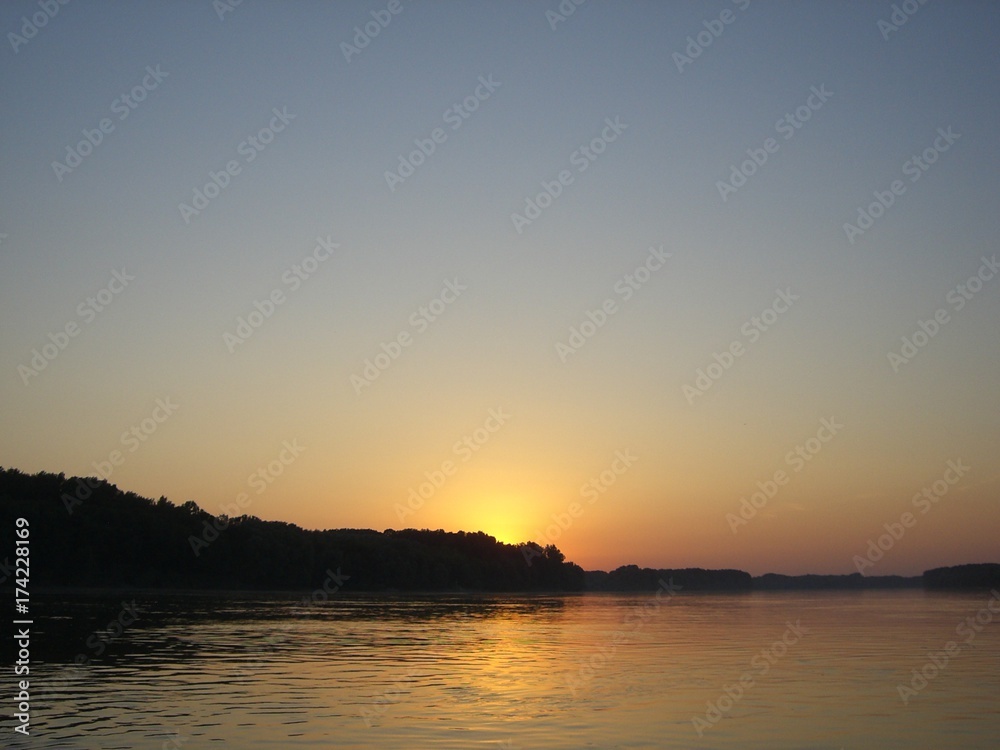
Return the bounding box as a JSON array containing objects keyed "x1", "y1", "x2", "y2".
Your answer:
[{"x1": 0, "y1": 467, "x2": 1000, "y2": 592}]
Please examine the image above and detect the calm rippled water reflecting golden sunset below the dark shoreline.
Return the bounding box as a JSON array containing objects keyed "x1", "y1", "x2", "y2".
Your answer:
[{"x1": 9, "y1": 591, "x2": 1000, "y2": 750}]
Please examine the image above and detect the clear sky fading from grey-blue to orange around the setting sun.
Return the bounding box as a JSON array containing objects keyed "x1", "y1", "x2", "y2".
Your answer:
[{"x1": 0, "y1": 0, "x2": 1000, "y2": 575}]
